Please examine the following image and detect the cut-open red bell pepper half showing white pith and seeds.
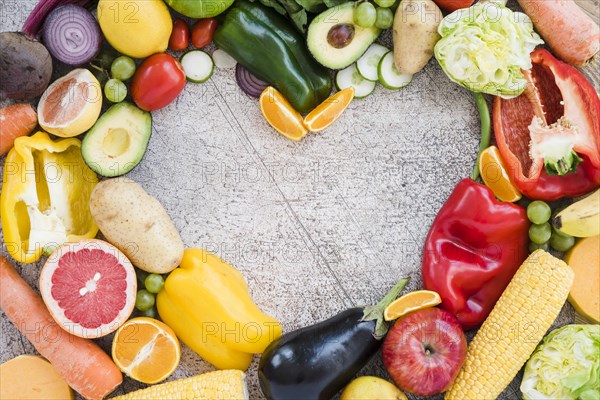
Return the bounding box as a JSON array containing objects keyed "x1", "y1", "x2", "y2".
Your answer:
[{"x1": 494, "y1": 49, "x2": 600, "y2": 201}]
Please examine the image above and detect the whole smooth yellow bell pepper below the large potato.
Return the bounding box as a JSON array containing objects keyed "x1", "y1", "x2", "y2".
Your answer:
[{"x1": 156, "y1": 249, "x2": 281, "y2": 370}]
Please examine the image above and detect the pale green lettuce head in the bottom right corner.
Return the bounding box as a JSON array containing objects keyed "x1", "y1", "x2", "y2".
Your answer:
[{"x1": 521, "y1": 324, "x2": 600, "y2": 400}]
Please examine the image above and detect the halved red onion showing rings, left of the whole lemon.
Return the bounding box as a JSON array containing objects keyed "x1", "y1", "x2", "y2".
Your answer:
[{"x1": 42, "y1": 4, "x2": 102, "y2": 65}]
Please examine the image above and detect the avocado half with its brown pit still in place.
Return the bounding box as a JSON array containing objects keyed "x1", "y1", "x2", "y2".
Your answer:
[{"x1": 306, "y1": 2, "x2": 381, "y2": 69}]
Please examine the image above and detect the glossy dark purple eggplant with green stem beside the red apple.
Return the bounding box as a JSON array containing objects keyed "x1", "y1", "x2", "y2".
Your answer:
[{"x1": 258, "y1": 278, "x2": 408, "y2": 400}]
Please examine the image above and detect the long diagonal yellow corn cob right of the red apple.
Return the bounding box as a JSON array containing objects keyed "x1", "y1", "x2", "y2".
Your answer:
[{"x1": 445, "y1": 250, "x2": 574, "y2": 400}]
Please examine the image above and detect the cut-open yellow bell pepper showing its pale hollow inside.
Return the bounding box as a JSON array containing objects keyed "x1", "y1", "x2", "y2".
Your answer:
[{"x1": 0, "y1": 132, "x2": 98, "y2": 263}]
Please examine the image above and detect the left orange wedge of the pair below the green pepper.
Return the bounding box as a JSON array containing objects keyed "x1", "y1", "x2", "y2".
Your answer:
[{"x1": 258, "y1": 86, "x2": 308, "y2": 142}]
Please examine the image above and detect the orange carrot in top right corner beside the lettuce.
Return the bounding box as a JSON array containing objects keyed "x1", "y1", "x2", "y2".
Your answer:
[{"x1": 518, "y1": 0, "x2": 600, "y2": 67}]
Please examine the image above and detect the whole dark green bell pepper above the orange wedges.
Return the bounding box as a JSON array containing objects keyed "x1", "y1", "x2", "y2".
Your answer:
[{"x1": 214, "y1": 0, "x2": 331, "y2": 113}]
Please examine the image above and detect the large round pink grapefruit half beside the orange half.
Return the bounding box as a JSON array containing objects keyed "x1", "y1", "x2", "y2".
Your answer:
[{"x1": 40, "y1": 239, "x2": 137, "y2": 339}]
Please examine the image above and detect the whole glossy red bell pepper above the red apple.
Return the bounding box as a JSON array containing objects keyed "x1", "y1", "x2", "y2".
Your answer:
[{"x1": 422, "y1": 178, "x2": 530, "y2": 329}]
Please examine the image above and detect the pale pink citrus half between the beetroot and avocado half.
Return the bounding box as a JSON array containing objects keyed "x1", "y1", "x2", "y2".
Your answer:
[{"x1": 37, "y1": 68, "x2": 102, "y2": 137}]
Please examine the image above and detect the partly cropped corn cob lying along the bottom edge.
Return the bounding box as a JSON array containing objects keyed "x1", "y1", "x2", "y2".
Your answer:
[{"x1": 110, "y1": 369, "x2": 248, "y2": 400}]
